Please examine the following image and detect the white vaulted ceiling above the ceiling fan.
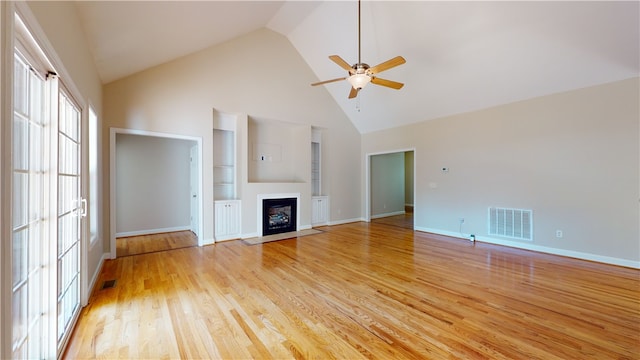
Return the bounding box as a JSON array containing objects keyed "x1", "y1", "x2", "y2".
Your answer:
[{"x1": 76, "y1": 1, "x2": 640, "y2": 133}]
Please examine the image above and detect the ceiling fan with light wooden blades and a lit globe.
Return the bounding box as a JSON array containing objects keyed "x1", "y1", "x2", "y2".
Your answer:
[{"x1": 311, "y1": 0, "x2": 406, "y2": 99}]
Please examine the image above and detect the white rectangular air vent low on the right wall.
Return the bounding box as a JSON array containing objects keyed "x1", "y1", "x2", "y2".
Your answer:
[{"x1": 489, "y1": 207, "x2": 533, "y2": 240}]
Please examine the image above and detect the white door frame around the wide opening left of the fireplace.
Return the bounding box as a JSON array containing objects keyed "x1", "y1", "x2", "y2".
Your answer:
[{"x1": 109, "y1": 128, "x2": 204, "y2": 259}]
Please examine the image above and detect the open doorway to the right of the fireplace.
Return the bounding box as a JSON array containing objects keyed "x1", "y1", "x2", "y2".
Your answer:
[{"x1": 366, "y1": 149, "x2": 415, "y2": 230}]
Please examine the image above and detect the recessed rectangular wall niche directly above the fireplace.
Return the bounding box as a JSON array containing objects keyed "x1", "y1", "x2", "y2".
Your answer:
[{"x1": 247, "y1": 116, "x2": 311, "y2": 183}]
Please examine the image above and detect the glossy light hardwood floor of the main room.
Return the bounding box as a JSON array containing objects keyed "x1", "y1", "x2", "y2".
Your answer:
[{"x1": 65, "y1": 223, "x2": 640, "y2": 359}]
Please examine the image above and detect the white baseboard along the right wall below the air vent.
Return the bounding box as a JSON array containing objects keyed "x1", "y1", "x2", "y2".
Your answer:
[{"x1": 415, "y1": 227, "x2": 640, "y2": 269}]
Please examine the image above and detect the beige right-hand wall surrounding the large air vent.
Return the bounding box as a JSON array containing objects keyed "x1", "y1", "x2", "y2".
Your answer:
[{"x1": 362, "y1": 78, "x2": 640, "y2": 266}]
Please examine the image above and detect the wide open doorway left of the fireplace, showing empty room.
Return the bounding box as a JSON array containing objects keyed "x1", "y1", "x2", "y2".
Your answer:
[{"x1": 110, "y1": 129, "x2": 203, "y2": 258}]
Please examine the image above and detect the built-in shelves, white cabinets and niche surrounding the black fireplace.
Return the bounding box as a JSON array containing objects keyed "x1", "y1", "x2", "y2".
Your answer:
[{"x1": 212, "y1": 109, "x2": 329, "y2": 241}]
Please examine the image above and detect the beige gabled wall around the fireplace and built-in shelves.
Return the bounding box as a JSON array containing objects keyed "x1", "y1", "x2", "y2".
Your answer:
[{"x1": 104, "y1": 29, "x2": 361, "y2": 242}]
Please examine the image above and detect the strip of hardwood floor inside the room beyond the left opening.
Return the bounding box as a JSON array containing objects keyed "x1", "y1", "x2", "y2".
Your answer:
[{"x1": 116, "y1": 231, "x2": 198, "y2": 257}]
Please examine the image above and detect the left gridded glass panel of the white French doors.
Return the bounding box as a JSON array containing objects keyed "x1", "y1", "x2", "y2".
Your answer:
[{"x1": 11, "y1": 53, "x2": 46, "y2": 358}]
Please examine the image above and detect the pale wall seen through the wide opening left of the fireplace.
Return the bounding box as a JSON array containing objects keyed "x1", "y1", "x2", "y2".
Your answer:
[{"x1": 116, "y1": 134, "x2": 196, "y2": 236}]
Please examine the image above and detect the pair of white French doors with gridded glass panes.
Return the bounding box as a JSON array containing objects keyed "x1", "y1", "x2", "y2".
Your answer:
[{"x1": 11, "y1": 21, "x2": 85, "y2": 359}]
